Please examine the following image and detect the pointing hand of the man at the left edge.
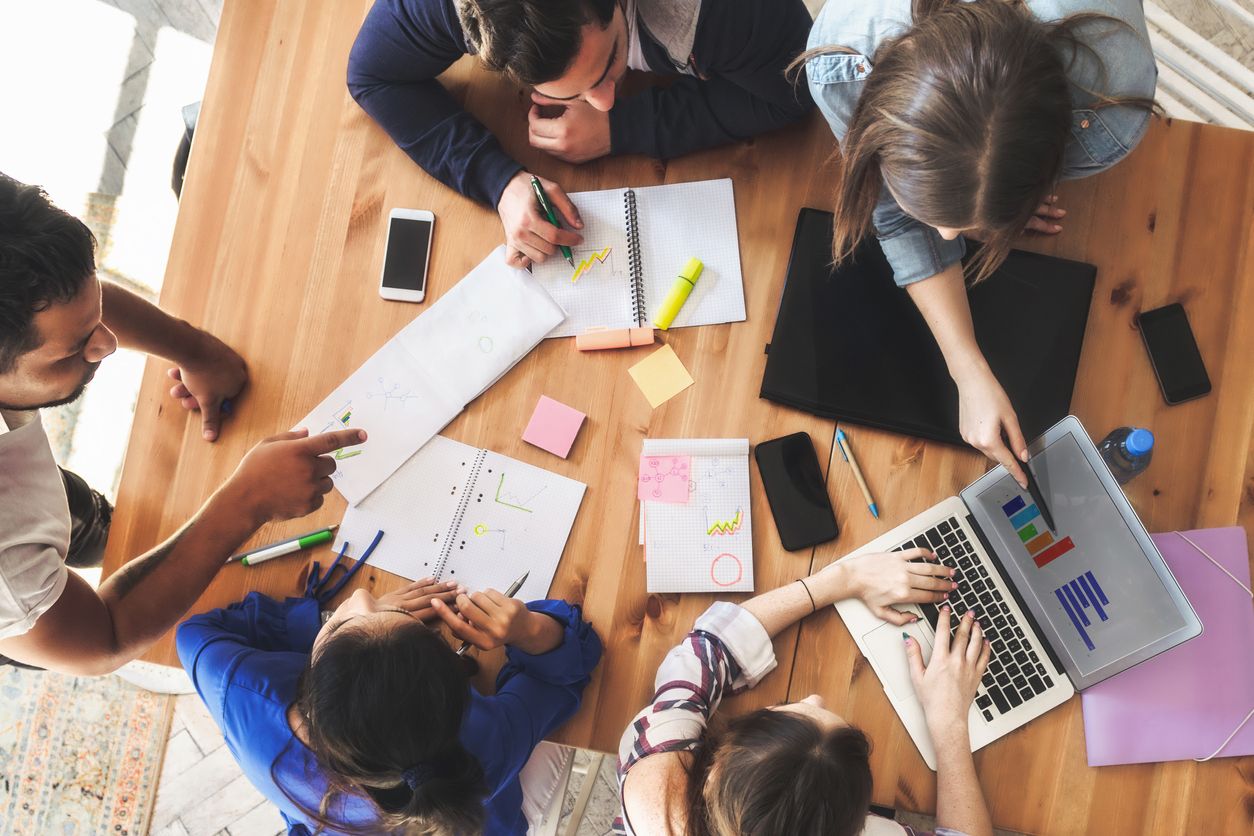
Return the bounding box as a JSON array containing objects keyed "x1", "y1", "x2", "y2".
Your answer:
[{"x1": 221, "y1": 429, "x2": 366, "y2": 528}]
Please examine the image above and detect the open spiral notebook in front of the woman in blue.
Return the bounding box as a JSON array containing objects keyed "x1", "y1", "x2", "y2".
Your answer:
[{"x1": 335, "y1": 435, "x2": 587, "y2": 598}]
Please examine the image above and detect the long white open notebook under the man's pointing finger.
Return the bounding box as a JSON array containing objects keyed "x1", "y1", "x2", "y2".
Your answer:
[{"x1": 296, "y1": 247, "x2": 563, "y2": 504}]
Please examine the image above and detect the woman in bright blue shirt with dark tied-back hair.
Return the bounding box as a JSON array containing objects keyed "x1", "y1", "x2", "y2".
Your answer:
[{"x1": 178, "y1": 579, "x2": 601, "y2": 836}]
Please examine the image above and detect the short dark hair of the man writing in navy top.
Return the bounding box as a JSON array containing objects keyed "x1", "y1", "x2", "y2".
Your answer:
[{"x1": 458, "y1": 0, "x2": 618, "y2": 86}]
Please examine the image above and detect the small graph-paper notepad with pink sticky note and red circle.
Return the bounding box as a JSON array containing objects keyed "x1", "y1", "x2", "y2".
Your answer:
[{"x1": 641, "y1": 439, "x2": 754, "y2": 592}]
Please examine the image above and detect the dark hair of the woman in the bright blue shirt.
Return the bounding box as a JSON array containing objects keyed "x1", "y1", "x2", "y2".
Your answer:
[{"x1": 277, "y1": 622, "x2": 488, "y2": 836}]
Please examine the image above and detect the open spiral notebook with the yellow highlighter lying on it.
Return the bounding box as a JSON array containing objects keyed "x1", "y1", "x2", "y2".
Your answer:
[{"x1": 533, "y1": 179, "x2": 745, "y2": 337}]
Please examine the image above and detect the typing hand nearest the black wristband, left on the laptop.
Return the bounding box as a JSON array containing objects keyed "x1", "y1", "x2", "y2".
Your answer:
[{"x1": 819, "y1": 549, "x2": 957, "y2": 625}]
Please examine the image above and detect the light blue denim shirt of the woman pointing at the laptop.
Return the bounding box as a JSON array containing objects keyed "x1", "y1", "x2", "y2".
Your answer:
[{"x1": 806, "y1": 0, "x2": 1157, "y2": 287}]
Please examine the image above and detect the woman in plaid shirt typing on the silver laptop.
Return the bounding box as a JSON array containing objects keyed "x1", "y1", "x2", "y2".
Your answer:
[{"x1": 614, "y1": 549, "x2": 992, "y2": 836}]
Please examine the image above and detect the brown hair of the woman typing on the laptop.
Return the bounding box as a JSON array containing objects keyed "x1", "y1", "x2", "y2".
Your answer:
[{"x1": 687, "y1": 708, "x2": 872, "y2": 836}]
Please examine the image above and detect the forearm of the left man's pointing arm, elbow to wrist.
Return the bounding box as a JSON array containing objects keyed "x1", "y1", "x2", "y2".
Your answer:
[{"x1": 98, "y1": 483, "x2": 260, "y2": 667}]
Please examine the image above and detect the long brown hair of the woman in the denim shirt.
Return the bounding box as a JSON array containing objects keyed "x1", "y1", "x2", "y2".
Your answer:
[{"x1": 790, "y1": 0, "x2": 1156, "y2": 282}]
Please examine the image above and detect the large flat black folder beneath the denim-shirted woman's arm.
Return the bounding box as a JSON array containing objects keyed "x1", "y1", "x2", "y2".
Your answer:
[{"x1": 761, "y1": 209, "x2": 1097, "y2": 444}]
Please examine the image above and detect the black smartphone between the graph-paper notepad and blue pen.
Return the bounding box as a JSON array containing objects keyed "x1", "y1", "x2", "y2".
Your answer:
[{"x1": 754, "y1": 432, "x2": 840, "y2": 551}]
